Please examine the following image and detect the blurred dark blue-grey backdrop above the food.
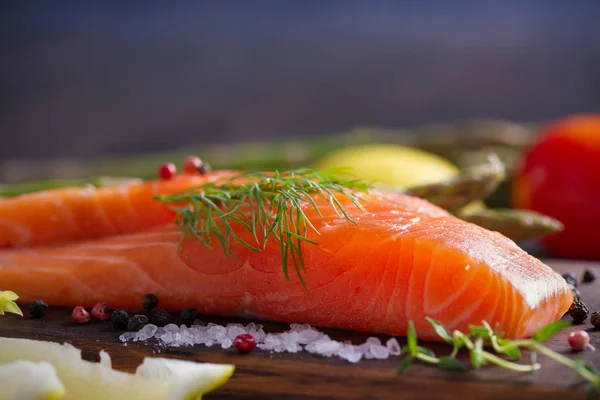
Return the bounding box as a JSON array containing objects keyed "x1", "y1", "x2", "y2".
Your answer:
[{"x1": 0, "y1": 0, "x2": 600, "y2": 160}]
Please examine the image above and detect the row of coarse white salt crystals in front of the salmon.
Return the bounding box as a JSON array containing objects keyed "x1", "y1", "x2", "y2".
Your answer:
[{"x1": 120, "y1": 320, "x2": 400, "y2": 363}]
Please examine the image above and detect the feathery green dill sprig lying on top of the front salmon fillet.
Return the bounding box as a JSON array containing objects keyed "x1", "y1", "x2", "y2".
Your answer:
[{"x1": 155, "y1": 169, "x2": 371, "y2": 289}]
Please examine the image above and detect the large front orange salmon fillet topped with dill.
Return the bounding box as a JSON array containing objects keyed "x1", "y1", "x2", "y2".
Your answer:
[{"x1": 0, "y1": 180, "x2": 573, "y2": 340}]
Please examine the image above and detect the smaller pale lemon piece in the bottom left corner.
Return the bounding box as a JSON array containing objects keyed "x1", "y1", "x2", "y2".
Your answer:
[{"x1": 0, "y1": 361, "x2": 65, "y2": 400}]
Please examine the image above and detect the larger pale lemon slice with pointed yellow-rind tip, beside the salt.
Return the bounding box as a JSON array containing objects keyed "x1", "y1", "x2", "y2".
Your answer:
[{"x1": 0, "y1": 338, "x2": 235, "y2": 400}]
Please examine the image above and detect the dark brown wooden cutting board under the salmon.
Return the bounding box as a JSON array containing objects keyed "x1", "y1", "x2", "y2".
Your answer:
[{"x1": 0, "y1": 260, "x2": 600, "y2": 400}]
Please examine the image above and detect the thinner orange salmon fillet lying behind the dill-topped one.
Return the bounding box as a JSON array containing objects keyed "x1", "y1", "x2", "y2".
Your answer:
[{"x1": 0, "y1": 170, "x2": 234, "y2": 248}]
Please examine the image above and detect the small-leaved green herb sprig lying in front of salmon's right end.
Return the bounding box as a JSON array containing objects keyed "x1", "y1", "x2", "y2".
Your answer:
[{"x1": 398, "y1": 318, "x2": 600, "y2": 396}]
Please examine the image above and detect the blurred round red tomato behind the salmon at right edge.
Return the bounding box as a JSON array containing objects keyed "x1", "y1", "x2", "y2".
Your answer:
[{"x1": 512, "y1": 114, "x2": 600, "y2": 260}]
